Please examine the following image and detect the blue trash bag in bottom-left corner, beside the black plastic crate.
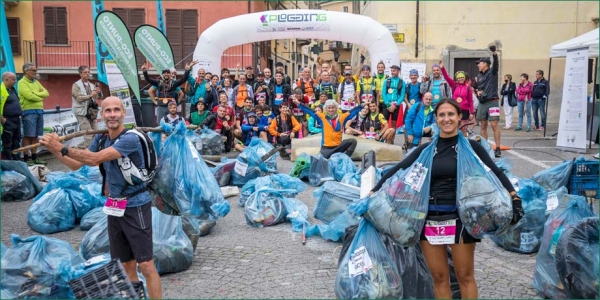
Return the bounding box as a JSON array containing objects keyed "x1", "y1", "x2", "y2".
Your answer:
[{"x1": 0, "y1": 234, "x2": 83, "y2": 299}]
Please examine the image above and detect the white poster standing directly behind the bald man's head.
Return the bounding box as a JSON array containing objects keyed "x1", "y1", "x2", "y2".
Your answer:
[{"x1": 96, "y1": 60, "x2": 135, "y2": 129}]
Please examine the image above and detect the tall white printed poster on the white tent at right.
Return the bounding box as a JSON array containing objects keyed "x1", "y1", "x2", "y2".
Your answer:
[{"x1": 556, "y1": 48, "x2": 589, "y2": 151}]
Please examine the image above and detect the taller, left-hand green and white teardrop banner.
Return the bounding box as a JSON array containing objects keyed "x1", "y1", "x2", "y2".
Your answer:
[{"x1": 94, "y1": 10, "x2": 141, "y2": 105}]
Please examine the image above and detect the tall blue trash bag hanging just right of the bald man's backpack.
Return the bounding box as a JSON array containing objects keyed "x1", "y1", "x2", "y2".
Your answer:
[{"x1": 150, "y1": 123, "x2": 229, "y2": 220}]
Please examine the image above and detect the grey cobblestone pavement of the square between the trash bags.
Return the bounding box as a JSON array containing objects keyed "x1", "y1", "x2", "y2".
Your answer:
[{"x1": 1, "y1": 123, "x2": 597, "y2": 299}]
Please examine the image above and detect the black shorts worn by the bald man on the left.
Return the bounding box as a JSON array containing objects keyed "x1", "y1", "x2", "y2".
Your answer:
[{"x1": 108, "y1": 202, "x2": 153, "y2": 263}]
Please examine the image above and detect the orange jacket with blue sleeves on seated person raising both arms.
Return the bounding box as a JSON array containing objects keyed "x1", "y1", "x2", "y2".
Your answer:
[{"x1": 300, "y1": 104, "x2": 363, "y2": 147}]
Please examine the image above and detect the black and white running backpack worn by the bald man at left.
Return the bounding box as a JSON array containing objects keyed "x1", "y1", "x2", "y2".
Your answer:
[{"x1": 98, "y1": 128, "x2": 158, "y2": 193}]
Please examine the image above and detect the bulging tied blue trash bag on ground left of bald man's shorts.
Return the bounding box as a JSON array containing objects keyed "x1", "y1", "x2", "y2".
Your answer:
[{"x1": 27, "y1": 166, "x2": 106, "y2": 234}]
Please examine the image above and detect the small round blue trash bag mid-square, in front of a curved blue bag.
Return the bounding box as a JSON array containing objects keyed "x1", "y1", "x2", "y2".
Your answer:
[{"x1": 244, "y1": 188, "x2": 291, "y2": 227}]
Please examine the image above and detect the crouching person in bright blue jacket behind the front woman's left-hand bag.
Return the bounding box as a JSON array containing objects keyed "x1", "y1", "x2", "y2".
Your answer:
[{"x1": 404, "y1": 92, "x2": 435, "y2": 150}]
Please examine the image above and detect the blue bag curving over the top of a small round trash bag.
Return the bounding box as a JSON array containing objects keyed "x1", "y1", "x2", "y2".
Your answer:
[{"x1": 238, "y1": 174, "x2": 307, "y2": 207}]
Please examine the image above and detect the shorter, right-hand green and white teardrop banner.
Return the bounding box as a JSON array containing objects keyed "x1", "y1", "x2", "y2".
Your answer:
[{"x1": 133, "y1": 24, "x2": 175, "y2": 74}]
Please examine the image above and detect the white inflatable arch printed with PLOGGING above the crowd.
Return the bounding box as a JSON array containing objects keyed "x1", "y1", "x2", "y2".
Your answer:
[{"x1": 192, "y1": 9, "x2": 400, "y2": 74}]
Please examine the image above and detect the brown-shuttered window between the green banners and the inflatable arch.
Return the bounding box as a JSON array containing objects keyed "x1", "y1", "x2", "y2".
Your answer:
[{"x1": 166, "y1": 9, "x2": 198, "y2": 69}]
